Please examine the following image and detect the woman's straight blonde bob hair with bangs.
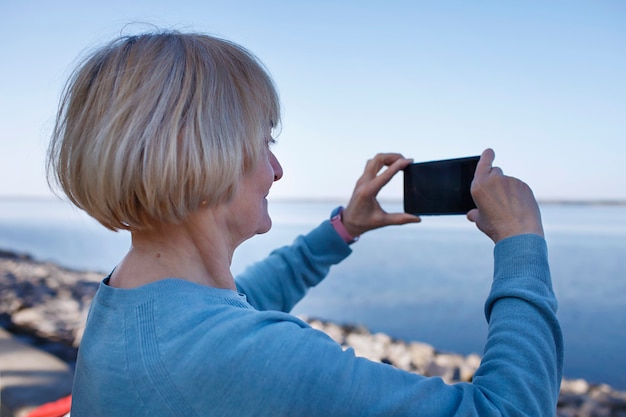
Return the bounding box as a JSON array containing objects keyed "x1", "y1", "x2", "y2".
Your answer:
[{"x1": 47, "y1": 31, "x2": 280, "y2": 231}]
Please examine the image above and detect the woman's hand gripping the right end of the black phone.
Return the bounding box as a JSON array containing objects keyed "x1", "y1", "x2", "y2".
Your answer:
[{"x1": 467, "y1": 149, "x2": 543, "y2": 243}]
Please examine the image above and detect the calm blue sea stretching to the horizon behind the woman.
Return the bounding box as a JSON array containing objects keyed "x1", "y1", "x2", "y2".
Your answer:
[{"x1": 0, "y1": 198, "x2": 626, "y2": 390}]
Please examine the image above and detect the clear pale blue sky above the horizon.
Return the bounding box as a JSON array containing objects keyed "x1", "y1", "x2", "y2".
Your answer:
[{"x1": 0, "y1": 0, "x2": 626, "y2": 202}]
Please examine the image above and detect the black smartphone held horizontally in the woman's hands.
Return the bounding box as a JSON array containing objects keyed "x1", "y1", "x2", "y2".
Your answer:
[{"x1": 404, "y1": 156, "x2": 480, "y2": 215}]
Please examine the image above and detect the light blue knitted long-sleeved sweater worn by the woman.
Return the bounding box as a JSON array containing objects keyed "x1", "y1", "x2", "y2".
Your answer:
[{"x1": 71, "y1": 222, "x2": 562, "y2": 417}]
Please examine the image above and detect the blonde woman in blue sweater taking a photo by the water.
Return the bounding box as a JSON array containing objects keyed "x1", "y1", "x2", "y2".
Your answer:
[{"x1": 48, "y1": 32, "x2": 562, "y2": 417}]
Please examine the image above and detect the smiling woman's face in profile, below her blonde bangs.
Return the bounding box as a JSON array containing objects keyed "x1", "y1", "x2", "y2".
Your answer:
[{"x1": 227, "y1": 139, "x2": 283, "y2": 240}]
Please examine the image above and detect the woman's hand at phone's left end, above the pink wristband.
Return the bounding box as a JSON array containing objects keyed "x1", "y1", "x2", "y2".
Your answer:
[{"x1": 342, "y1": 153, "x2": 420, "y2": 236}]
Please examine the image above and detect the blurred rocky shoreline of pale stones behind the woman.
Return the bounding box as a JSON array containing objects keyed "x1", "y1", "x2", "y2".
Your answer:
[{"x1": 0, "y1": 250, "x2": 626, "y2": 417}]
